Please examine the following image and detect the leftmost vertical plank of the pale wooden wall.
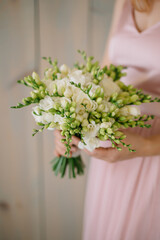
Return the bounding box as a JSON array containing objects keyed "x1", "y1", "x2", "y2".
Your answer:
[{"x1": 0, "y1": 0, "x2": 40, "y2": 240}]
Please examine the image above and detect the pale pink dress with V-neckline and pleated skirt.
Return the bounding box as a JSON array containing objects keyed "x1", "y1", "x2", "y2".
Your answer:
[{"x1": 83, "y1": 0, "x2": 160, "y2": 240}]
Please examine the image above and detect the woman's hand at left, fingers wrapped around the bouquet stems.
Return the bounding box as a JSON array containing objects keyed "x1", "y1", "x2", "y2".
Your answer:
[{"x1": 54, "y1": 130, "x2": 79, "y2": 157}]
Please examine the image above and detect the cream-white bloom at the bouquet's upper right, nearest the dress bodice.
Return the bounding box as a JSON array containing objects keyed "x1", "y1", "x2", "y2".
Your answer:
[{"x1": 100, "y1": 75, "x2": 121, "y2": 97}]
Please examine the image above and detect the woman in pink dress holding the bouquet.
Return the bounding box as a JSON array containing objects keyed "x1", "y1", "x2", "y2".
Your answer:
[{"x1": 55, "y1": 0, "x2": 160, "y2": 240}]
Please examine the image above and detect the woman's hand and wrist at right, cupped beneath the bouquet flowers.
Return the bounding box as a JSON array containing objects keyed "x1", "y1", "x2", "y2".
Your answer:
[{"x1": 80, "y1": 130, "x2": 150, "y2": 163}]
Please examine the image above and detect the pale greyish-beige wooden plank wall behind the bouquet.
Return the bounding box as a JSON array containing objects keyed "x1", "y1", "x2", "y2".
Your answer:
[{"x1": 0, "y1": 0, "x2": 114, "y2": 240}]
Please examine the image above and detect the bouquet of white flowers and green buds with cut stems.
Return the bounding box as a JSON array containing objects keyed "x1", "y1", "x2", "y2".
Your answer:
[{"x1": 12, "y1": 51, "x2": 160, "y2": 178}]
